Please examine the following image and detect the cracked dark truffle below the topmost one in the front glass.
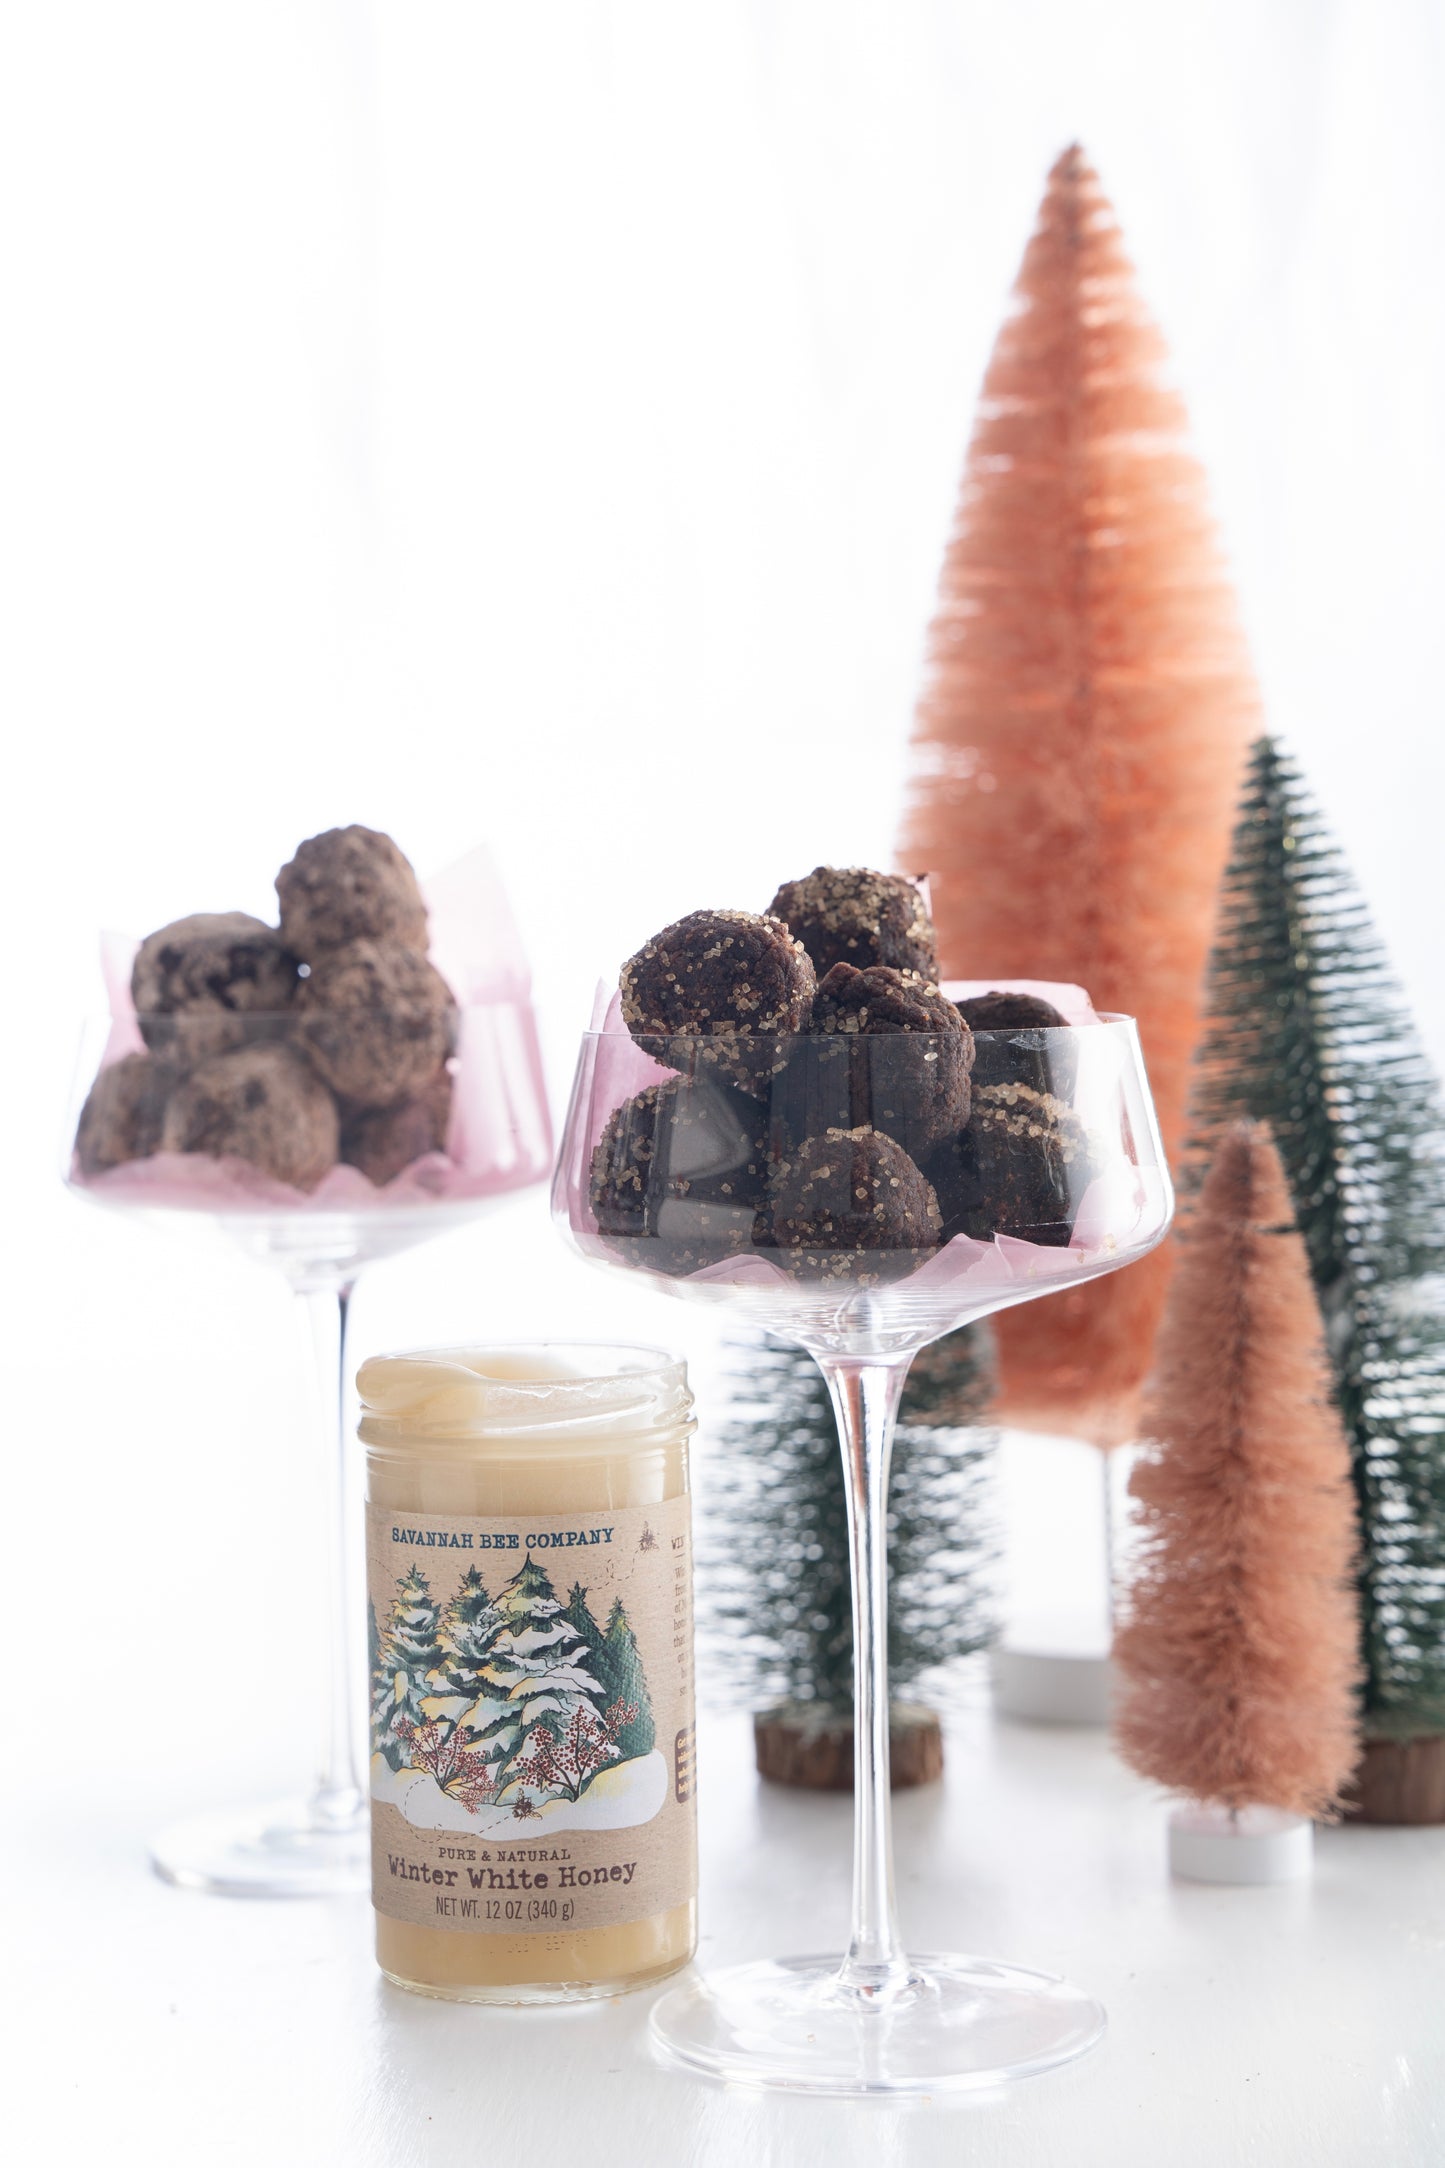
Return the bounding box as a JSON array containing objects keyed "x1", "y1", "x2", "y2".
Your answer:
[{"x1": 810, "y1": 963, "x2": 973, "y2": 1156}]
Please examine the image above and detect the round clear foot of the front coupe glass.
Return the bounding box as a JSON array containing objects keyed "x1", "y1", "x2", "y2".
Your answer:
[{"x1": 652, "y1": 1958, "x2": 1105, "y2": 2096}]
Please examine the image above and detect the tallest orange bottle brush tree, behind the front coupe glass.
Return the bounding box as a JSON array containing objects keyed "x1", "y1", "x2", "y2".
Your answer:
[{"x1": 901, "y1": 147, "x2": 1259, "y2": 1446}]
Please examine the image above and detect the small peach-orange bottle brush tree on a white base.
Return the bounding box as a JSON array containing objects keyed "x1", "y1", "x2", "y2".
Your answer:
[{"x1": 1114, "y1": 1123, "x2": 1358, "y2": 1817}]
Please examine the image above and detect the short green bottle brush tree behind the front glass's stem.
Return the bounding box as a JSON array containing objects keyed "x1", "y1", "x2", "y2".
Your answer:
[{"x1": 700, "y1": 1325, "x2": 994, "y2": 1791}]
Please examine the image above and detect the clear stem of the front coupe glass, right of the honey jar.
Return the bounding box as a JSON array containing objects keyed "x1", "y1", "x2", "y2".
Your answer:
[{"x1": 817, "y1": 1355, "x2": 910, "y2": 2005}]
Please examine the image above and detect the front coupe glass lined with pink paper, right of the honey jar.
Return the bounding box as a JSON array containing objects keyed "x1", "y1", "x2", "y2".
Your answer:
[{"x1": 552, "y1": 1005, "x2": 1172, "y2": 2096}]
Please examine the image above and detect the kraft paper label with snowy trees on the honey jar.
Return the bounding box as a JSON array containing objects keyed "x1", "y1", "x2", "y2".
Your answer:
[{"x1": 366, "y1": 1498, "x2": 698, "y2": 1934}]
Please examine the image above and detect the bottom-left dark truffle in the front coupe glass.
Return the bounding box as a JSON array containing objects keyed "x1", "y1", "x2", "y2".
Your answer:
[{"x1": 589, "y1": 1075, "x2": 769, "y2": 1275}]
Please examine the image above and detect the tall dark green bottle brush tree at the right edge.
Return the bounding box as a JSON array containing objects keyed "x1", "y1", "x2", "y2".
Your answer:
[{"x1": 1185, "y1": 737, "x2": 1445, "y2": 1821}]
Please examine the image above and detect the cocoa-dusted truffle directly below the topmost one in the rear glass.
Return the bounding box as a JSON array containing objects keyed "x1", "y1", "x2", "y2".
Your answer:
[{"x1": 295, "y1": 941, "x2": 455, "y2": 1108}]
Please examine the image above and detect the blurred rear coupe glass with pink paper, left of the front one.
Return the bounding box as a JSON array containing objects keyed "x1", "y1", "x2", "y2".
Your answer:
[{"x1": 65, "y1": 995, "x2": 552, "y2": 1897}]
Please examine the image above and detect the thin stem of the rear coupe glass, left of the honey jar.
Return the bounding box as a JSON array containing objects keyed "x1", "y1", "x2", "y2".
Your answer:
[{"x1": 301, "y1": 1279, "x2": 366, "y2": 1830}]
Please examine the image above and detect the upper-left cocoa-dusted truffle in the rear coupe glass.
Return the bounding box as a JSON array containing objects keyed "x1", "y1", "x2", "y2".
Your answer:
[{"x1": 130, "y1": 911, "x2": 297, "y2": 1062}]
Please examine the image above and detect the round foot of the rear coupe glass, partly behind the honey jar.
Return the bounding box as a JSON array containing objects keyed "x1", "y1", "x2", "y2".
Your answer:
[{"x1": 149, "y1": 1799, "x2": 370, "y2": 1897}]
